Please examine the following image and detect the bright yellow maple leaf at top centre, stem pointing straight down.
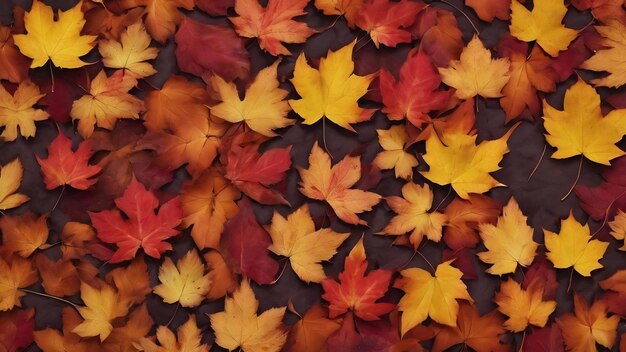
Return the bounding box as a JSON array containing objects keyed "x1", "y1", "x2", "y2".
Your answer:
[{"x1": 289, "y1": 40, "x2": 375, "y2": 132}]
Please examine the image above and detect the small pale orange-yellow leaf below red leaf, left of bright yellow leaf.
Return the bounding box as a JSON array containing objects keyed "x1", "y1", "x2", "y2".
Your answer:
[{"x1": 372, "y1": 125, "x2": 417, "y2": 180}]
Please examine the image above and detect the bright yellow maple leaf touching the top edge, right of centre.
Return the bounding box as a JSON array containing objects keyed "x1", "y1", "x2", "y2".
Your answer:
[{"x1": 509, "y1": 0, "x2": 578, "y2": 57}]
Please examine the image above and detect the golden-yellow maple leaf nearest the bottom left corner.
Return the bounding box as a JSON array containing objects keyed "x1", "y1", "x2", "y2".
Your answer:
[{"x1": 72, "y1": 282, "x2": 129, "y2": 341}]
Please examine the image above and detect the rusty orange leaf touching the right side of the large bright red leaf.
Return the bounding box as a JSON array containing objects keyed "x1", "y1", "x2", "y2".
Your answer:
[{"x1": 180, "y1": 168, "x2": 241, "y2": 249}]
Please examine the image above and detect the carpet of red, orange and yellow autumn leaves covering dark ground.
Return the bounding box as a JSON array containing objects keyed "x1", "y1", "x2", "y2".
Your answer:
[{"x1": 0, "y1": 0, "x2": 626, "y2": 352}]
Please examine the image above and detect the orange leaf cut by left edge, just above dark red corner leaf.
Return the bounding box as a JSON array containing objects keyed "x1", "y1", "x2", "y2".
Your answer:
[{"x1": 0, "y1": 255, "x2": 38, "y2": 312}]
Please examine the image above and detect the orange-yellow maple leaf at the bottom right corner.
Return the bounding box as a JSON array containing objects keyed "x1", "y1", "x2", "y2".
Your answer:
[{"x1": 556, "y1": 293, "x2": 620, "y2": 352}]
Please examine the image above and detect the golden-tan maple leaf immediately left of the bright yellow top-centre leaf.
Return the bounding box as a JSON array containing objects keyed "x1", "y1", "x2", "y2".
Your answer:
[{"x1": 211, "y1": 60, "x2": 295, "y2": 137}]
